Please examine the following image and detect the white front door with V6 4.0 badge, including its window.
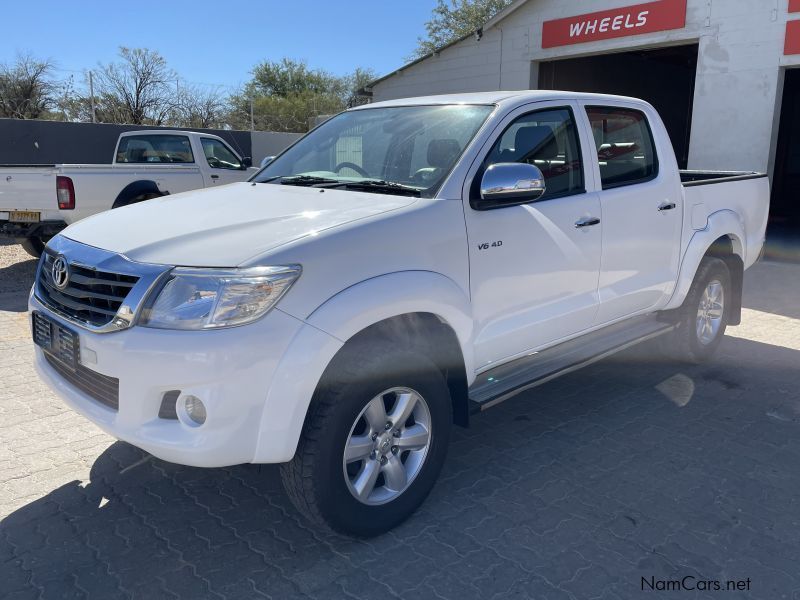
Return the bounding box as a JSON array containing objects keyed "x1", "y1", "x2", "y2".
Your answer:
[{"x1": 464, "y1": 102, "x2": 602, "y2": 370}]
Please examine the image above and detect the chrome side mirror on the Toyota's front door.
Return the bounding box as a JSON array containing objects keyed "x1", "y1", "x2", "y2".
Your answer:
[{"x1": 473, "y1": 163, "x2": 547, "y2": 210}]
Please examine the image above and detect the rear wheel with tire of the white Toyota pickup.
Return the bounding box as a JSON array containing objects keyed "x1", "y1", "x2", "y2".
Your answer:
[{"x1": 663, "y1": 256, "x2": 733, "y2": 363}]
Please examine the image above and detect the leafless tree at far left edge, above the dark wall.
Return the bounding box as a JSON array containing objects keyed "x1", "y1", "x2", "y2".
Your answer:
[{"x1": 0, "y1": 55, "x2": 56, "y2": 119}]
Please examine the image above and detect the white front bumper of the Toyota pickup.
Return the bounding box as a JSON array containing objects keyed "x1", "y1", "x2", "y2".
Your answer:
[{"x1": 30, "y1": 295, "x2": 318, "y2": 467}]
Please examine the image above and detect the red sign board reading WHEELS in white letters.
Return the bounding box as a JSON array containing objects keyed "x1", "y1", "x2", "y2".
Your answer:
[{"x1": 542, "y1": 0, "x2": 687, "y2": 48}]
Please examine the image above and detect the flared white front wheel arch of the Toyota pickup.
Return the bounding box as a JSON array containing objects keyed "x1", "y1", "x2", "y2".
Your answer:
[{"x1": 253, "y1": 271, "x2": 474, "y2": 462}]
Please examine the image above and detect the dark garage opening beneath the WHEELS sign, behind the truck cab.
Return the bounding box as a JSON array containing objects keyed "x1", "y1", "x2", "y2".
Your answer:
[{"x1": 539, "y1": 44, "x2": 698, "y2": 169}]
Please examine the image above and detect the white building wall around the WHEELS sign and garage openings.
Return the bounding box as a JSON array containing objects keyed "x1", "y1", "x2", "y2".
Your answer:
[{"x1": 373, "y1": 0, "x2": 800, "y2": 171}]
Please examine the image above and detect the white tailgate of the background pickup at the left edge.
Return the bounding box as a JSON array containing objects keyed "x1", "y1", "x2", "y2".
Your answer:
[{"x1": 0, "y1": 165, "x2": 58, "y2": 214}]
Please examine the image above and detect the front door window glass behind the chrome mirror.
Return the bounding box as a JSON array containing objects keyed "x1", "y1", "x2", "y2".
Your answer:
[{"x1": 483, "y1": 108, "x2": 584, "y2": 199}]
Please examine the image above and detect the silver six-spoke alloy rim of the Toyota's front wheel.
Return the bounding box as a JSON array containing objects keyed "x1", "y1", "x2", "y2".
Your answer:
[{"x1": 342, "y1": 387, "x2": 432, "y2": 505}]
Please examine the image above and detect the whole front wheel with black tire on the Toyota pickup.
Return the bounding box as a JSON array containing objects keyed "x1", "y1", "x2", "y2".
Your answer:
[{"x1": 281, "y1": 345, "x2": 452, "y2": 537}]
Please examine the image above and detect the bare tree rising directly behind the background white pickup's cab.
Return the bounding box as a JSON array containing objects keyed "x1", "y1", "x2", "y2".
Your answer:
[{"x1": 95, "y1": 47, "x2": 178, "y2": 125}]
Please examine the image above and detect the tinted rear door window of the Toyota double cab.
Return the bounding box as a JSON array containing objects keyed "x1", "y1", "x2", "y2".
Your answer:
[{"x1": 586, "y1": 106, "x2": 658, "y2": 189}]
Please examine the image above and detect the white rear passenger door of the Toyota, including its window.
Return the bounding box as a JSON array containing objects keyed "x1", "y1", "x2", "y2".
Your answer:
[{"x1": 582, "y1": 102, "x2": 684, "y2": 325}]
